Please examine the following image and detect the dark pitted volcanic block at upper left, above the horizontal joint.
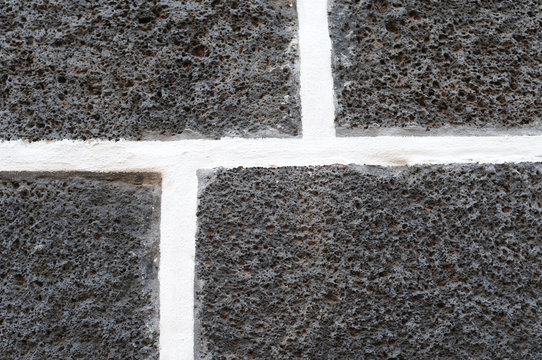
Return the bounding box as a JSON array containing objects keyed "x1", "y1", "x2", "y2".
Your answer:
[{"x1": 0, "y1": 0, "x2": 300, "y2": 140}]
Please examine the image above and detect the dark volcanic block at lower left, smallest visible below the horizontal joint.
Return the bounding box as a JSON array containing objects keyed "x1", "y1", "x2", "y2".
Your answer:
[{"x1": 0, "y1": 173, "x2": 160, "y2": 360}]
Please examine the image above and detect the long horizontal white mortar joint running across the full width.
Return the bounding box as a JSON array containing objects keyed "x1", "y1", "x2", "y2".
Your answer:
[{"x1": 0, "y1": 136, "x2": 542, "y2": 172}]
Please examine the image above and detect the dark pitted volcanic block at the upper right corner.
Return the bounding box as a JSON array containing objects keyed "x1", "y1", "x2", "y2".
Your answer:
[{"x1": 330, "y1": 0, "x2": 542, "y2": 135}]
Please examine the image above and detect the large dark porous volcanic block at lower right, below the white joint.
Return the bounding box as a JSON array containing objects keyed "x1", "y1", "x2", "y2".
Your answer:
[{"x1": 196, "y1": 164, "x2": 542, "y2": 359}]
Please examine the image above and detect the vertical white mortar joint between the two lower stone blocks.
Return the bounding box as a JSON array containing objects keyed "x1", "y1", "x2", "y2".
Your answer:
[{"x1": 159, "y1": 167, "x2": 198, "y2": 360}]
